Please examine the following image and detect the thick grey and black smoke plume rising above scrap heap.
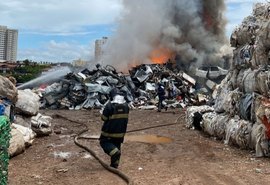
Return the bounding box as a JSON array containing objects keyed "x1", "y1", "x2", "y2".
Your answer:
[{"x1": 102, "y1": 0, "x2": 226, "y2": 70}]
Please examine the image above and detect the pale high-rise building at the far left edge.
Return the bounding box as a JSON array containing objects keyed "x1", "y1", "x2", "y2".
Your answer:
[{"x1": 0, "y1": 26, "x2": 18, "y2": 62}]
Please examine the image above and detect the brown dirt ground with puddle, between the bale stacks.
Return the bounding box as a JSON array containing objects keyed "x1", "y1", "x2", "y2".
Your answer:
[{"x1": 6, "y1": 110, "x2": 270, "y2": 185}]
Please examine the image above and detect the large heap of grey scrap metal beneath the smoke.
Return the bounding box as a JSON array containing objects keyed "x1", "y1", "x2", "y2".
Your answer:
[{"x1": 39, "y1": 64, "x2": 207, "y2": 110}]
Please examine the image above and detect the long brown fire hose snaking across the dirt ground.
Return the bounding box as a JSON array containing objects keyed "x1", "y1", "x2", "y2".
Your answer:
[{"x1": 53, "y1": 114, "x2": 182, "y2": 185}]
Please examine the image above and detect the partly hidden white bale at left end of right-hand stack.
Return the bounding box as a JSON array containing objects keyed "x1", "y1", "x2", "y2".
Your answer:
[{"x1": 186, "y1": 105, "x2": 214, "y2": 128}]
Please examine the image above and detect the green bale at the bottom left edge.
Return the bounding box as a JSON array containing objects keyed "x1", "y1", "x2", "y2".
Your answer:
[{"x1": 0, "y1": 115, "x2": 11, "y2": 184}]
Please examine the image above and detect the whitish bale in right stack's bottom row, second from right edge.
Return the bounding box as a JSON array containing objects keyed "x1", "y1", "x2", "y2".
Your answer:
[{"x1": 224, "y1": 116, "x2": 252, "y2": 149}]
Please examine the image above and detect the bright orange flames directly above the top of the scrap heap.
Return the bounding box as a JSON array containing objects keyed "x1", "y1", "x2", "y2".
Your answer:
[{"x1": 149, "y1": 48, "x2": 173, "y2": 64}]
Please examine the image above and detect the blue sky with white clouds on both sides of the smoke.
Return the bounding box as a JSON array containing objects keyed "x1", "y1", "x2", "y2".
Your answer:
[{"x1": 0, "y1": 0, "x2": 266, "y2": 62}]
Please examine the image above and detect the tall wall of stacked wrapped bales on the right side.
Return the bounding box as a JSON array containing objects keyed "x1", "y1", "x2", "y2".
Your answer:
[{"x1": 186, "y1": 3, "x2": 270, "y2": 157}]
